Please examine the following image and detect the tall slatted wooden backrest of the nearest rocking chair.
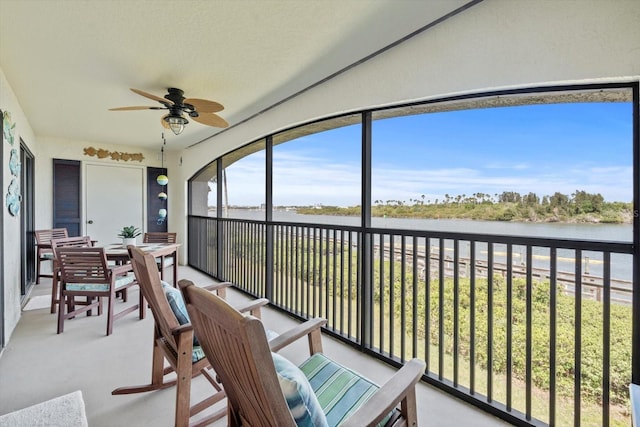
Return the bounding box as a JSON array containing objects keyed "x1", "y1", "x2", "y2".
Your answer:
[{"x1": 180, "y1": 280, "x2": 295, "y2": 427}]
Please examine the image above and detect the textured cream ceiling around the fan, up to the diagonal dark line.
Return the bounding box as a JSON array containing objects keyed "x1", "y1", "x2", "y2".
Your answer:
[{"x1": 0, "y1": 0, "x2": 468, "y2": 148}]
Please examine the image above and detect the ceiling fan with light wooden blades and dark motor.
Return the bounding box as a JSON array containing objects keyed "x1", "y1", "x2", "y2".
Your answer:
[{"x1": 109, "y1": 87, "x2": 229, "y2": 135}]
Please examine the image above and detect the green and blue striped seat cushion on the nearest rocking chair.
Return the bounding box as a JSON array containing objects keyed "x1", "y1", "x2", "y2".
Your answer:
[{"x1": 300, "y1": 353, "x2": 393, "y2": 426}]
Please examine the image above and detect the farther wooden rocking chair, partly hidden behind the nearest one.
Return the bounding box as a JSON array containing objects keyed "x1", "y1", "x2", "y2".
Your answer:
[{"x1": 111, "y1": 246, "x2": 267, "y2": 427}]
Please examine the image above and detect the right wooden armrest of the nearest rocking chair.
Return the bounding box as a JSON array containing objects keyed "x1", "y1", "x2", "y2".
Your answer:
[{"x1": 341, "y1": 359, "x2": 426, "y2": 427}]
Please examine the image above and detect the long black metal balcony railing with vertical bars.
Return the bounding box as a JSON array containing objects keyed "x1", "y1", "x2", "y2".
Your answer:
[{"x1": 188, "y1": 216, "x2": 634, "y2": 426}]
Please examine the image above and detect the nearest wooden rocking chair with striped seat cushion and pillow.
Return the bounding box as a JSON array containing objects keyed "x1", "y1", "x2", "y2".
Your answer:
[{"x1": 179, "y1": 280, "x2": 425, "y2": 427}]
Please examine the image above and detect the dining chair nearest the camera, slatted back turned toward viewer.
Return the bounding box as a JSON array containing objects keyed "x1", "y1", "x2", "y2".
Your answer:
[{"x1": 55, "y1": 247, "x2": 144, "y2": 335}]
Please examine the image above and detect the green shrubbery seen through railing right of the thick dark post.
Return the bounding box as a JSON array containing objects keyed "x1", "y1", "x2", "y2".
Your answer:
[{"x1": 387, "y1": 276, "x2": 632, "y2": 404}]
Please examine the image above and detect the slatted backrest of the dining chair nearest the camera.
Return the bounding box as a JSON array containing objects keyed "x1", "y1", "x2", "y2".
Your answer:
[{"x1": 55, "y1": 247, "x2": 111, "y2": 284}]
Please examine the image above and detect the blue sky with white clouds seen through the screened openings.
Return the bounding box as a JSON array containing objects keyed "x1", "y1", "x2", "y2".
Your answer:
[{"x1": 219, "y1": 103, "x2": 633, "y2": 206}]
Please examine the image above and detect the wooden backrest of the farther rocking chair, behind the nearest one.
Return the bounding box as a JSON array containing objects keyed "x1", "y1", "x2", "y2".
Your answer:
[{"x1": 127, "y1": 246, "x2": 180, "y2": 351}]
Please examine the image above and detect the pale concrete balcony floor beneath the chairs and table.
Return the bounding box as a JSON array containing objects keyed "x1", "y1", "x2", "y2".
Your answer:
[{"x1": 0, "y1": 266, "x2": 507, "y2": 427}]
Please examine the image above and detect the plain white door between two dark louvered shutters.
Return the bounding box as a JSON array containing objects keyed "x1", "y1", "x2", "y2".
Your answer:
[{"x1": 85, "y1": 163, "x2": 146, "y2": 245}]
